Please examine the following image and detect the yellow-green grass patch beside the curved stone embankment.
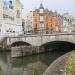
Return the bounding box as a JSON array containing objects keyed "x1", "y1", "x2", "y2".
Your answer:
[{"x1": 66, "y1": 53, "x2": 75, "y2": 75}]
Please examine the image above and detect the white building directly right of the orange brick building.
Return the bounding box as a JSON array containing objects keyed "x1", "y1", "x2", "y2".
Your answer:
[{"x1": 62, "y1": 13, "x2": 72, "y2": 32}]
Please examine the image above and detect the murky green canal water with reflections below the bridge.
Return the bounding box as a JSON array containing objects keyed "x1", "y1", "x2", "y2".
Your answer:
[{"x1": 0, "y1": 52, "x2": 68, "y2": 75}]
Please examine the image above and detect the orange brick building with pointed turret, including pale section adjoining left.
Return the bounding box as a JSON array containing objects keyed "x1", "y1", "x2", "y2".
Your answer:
[{"x1": 25, "y1": 3, "x2": 62, "y2": 34}]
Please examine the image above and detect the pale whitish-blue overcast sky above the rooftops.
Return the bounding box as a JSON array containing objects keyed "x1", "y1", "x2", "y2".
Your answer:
[{"x1": 21, "y1": 0, "x2": 75, "y2": 17}]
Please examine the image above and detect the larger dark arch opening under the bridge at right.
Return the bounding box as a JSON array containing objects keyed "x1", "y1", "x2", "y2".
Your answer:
[{"x1": 40, "y1": 40, "x2": 75, "y2": 51}]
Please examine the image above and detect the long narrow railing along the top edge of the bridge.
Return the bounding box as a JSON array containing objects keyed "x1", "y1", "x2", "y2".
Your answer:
[{"x1": 0, "y1": 32, "x2": 75, "y2": 38}]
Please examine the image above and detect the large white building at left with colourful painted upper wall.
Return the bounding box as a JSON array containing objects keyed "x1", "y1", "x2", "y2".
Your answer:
[{"x1": 0, "y1": 0, "x2": 22, "y2": 38}]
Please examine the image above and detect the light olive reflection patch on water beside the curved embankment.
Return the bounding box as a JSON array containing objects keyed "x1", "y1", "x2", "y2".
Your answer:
[{"x1": 26, "y1": 61, "x2": 47, "y2": 75}]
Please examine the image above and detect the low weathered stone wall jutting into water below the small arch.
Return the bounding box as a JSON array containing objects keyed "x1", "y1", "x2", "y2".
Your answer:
[{"x1": 11, "y1": 46, "x2": 44, "y2": 57}]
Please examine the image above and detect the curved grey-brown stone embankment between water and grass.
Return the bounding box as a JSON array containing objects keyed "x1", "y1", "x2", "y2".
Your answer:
[{"x1": 43, "y1": 50, "x2": 75, "y2": 75}]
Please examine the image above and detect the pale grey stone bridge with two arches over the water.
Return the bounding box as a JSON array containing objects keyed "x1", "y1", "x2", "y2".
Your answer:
[{"x1": 1, "y1": 33, "x2": 75, "y2": 46}]
